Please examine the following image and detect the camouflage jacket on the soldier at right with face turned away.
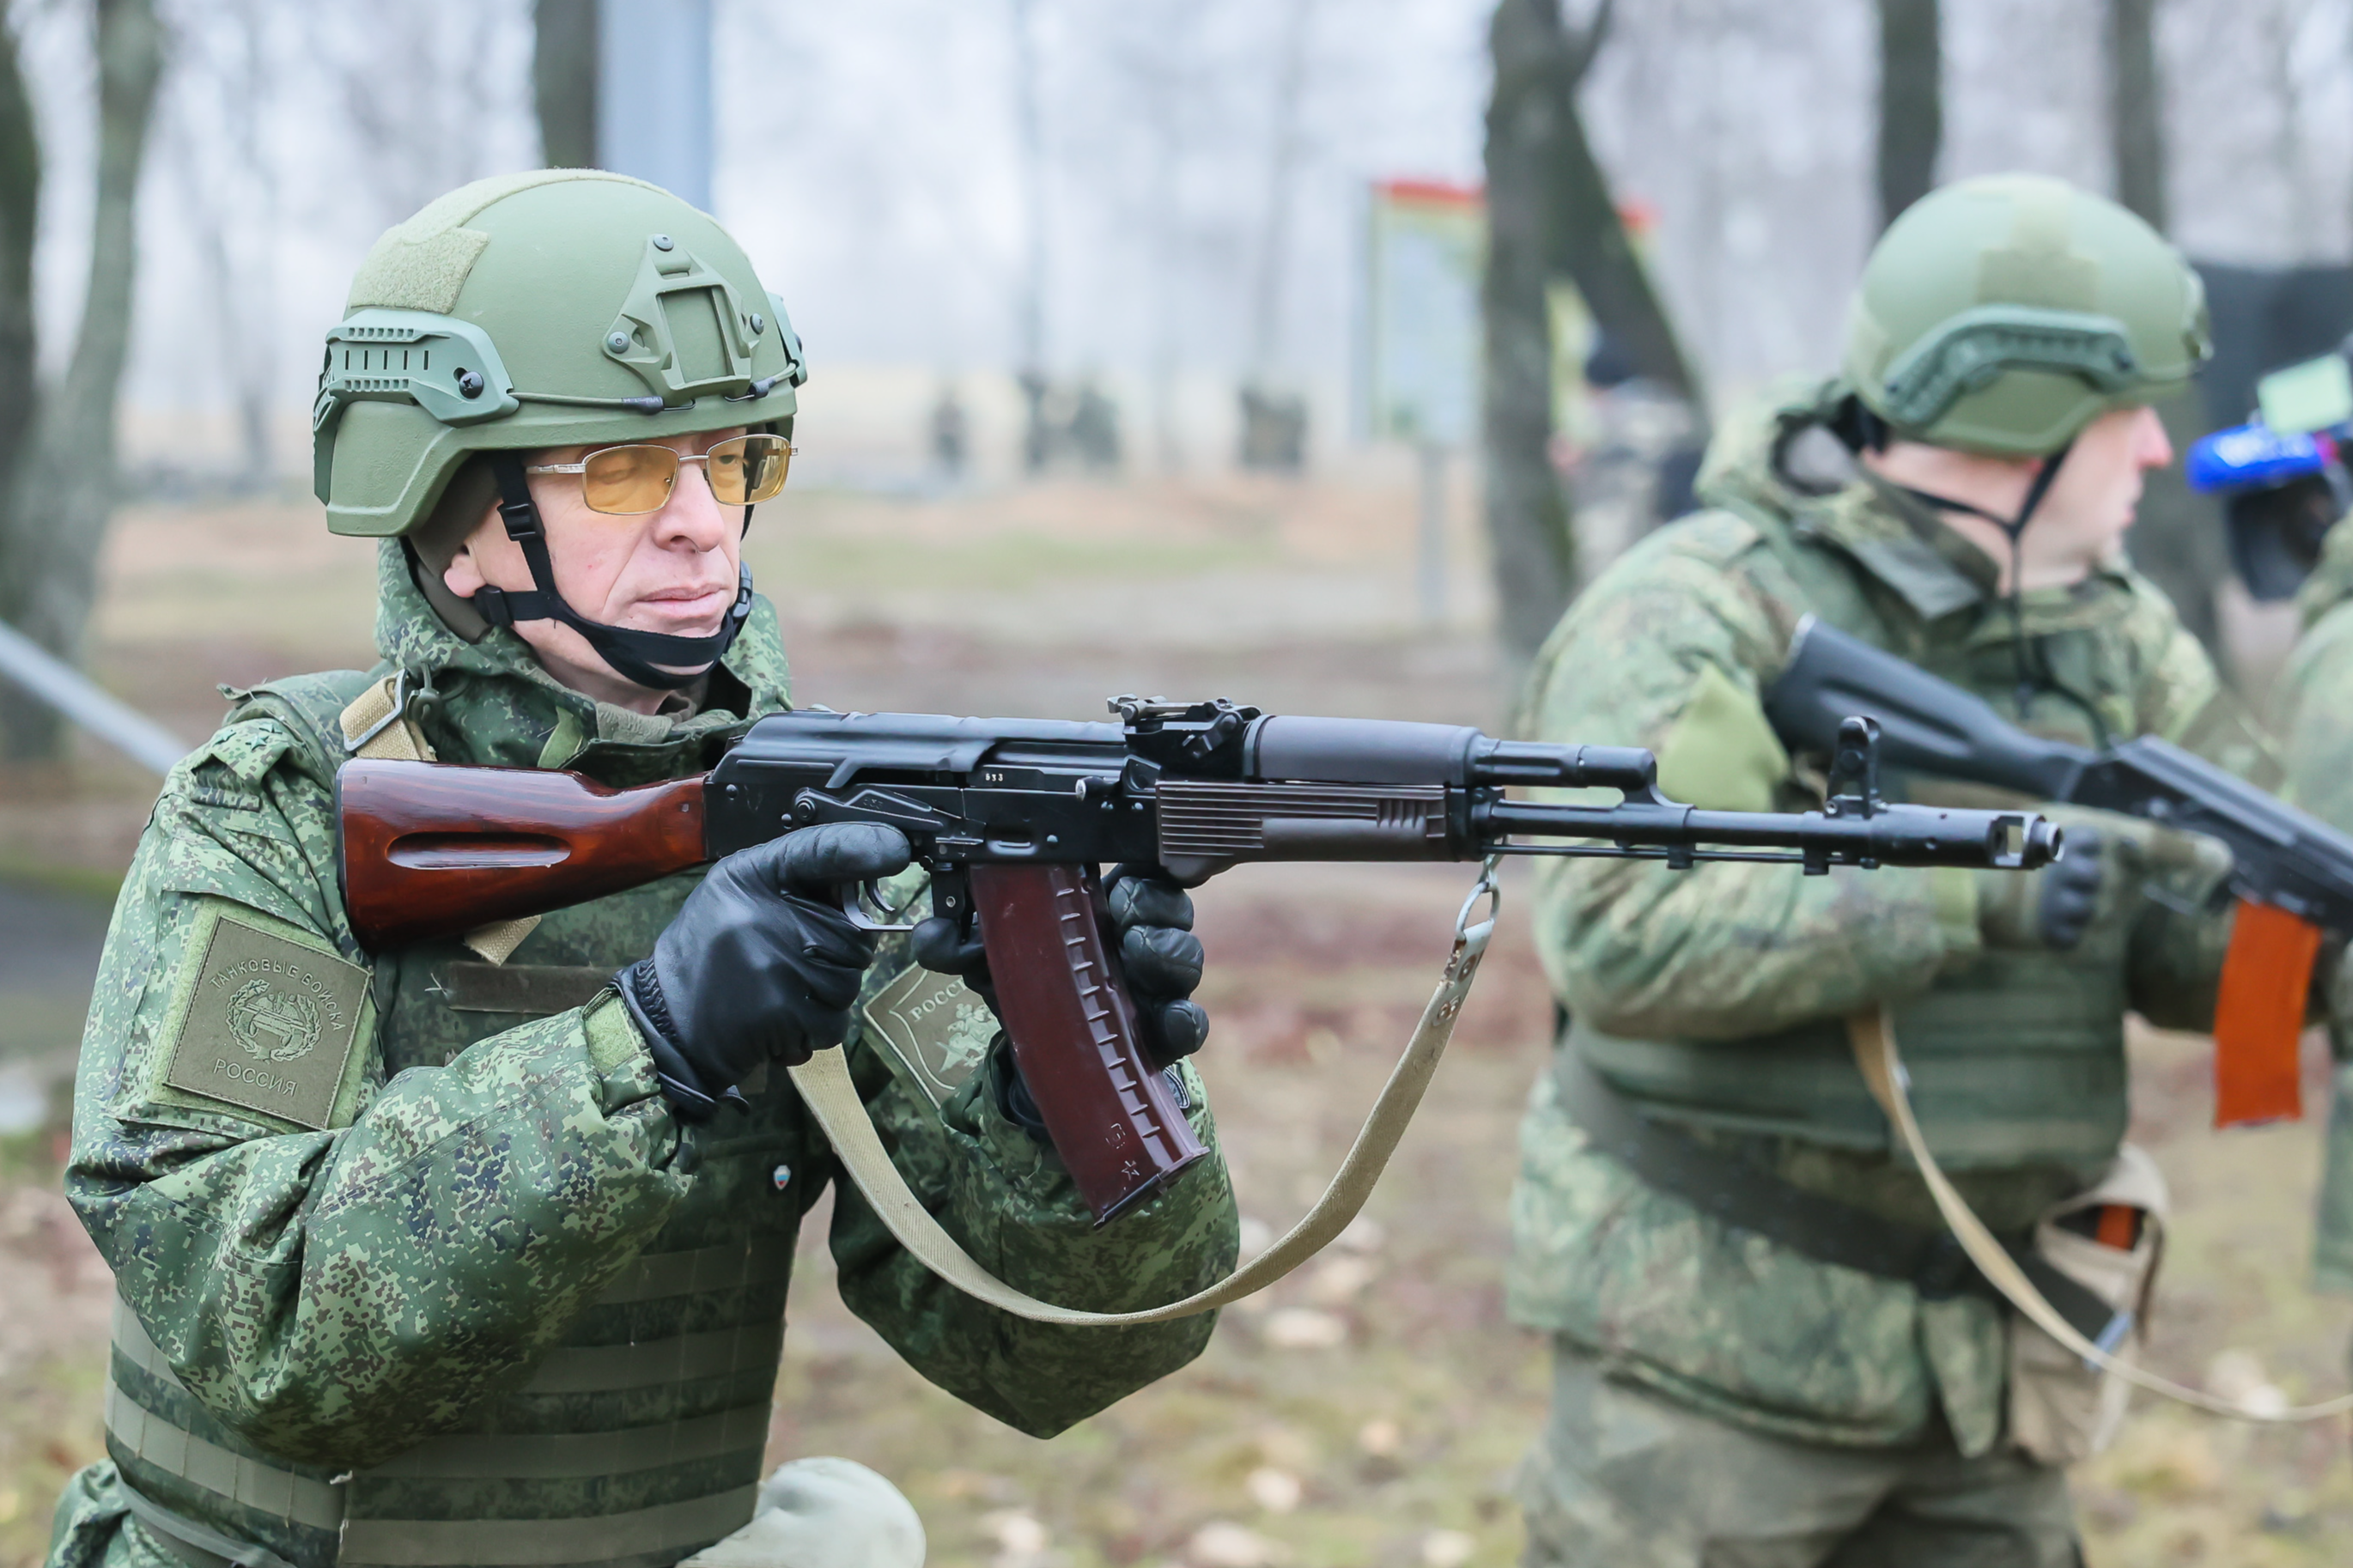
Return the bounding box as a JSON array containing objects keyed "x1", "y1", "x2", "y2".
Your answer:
[{"x1": 1508, "y1": 386, "x2": 2261, "y2": 1455}]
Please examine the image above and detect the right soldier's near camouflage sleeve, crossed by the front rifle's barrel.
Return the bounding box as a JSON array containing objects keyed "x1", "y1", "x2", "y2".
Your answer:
[{"x1": 1529, "y1": 523, "x2": 1979, "y2": 1038}]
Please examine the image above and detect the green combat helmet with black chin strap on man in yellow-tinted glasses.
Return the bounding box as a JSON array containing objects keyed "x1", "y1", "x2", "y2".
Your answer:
[{"x1": 311, "y1": 169, "x2": 807, "y2": 688}]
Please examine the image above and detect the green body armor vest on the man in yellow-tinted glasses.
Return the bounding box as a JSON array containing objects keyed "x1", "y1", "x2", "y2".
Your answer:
[{"x1": 106, "y1": 683, "x2": 826, "y2": 1568}]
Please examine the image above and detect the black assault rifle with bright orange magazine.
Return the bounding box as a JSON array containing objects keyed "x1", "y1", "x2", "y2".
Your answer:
[{"x1": 1765, "y1": 617, "x2": 2353, "y2": 1126}]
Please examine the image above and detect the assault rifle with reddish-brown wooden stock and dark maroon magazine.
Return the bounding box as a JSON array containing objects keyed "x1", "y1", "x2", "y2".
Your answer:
[{"x1": 337, "y1": 697, "x2": 2059, "y2": 1222}]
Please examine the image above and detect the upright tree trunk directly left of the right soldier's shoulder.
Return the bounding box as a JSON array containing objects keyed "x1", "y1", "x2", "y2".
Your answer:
[{"x1": 1480, "y1": 0, "x2": 1577, "y2": 680}]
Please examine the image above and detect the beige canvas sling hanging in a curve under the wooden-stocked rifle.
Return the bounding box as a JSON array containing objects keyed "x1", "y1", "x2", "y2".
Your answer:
[{"x1": 791, "y1": 861, "x2": 1499, "y2": 1328}]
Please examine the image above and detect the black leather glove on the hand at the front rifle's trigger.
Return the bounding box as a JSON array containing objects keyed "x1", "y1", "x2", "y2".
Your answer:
[{"x1": 614, "y1": 822, "x2": 910, "y2": 1121}]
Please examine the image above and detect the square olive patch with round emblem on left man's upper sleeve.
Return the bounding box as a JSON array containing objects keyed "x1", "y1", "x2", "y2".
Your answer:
[{"x1": 165, "y1": 916, "x2": 367, "y2": 1127}]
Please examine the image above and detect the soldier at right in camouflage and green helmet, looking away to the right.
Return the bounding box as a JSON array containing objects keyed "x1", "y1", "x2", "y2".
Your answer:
[{"x1": 1508, "y1": 177, "x2": 2259, "y2": 1568}]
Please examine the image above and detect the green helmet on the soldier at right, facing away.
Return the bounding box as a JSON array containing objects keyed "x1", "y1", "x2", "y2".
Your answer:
[{"x1": 1845, "y1": 174, "x2": 2212, "y2": 457}]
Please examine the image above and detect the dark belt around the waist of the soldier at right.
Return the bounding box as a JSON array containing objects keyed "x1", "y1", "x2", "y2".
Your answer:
[{"x1": 1553, "y1": 1048, "x2": 2115, "y2": 1340}]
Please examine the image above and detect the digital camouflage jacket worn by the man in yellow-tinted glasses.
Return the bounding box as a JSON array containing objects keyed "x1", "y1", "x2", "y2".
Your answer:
[{"x1": 52, "y1": 542, "x2": 1236, "y2": 1568}]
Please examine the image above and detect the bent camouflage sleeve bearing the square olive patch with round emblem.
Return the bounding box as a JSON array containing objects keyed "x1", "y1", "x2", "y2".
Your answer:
[{"x1": 66, "y1": 720, "x2": 684, "y2": 1467}]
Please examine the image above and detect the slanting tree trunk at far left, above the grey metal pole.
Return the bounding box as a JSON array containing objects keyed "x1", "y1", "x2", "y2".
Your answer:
[{"x1": 0, "y1": 0, "x2": 162, "y2": 758}]
